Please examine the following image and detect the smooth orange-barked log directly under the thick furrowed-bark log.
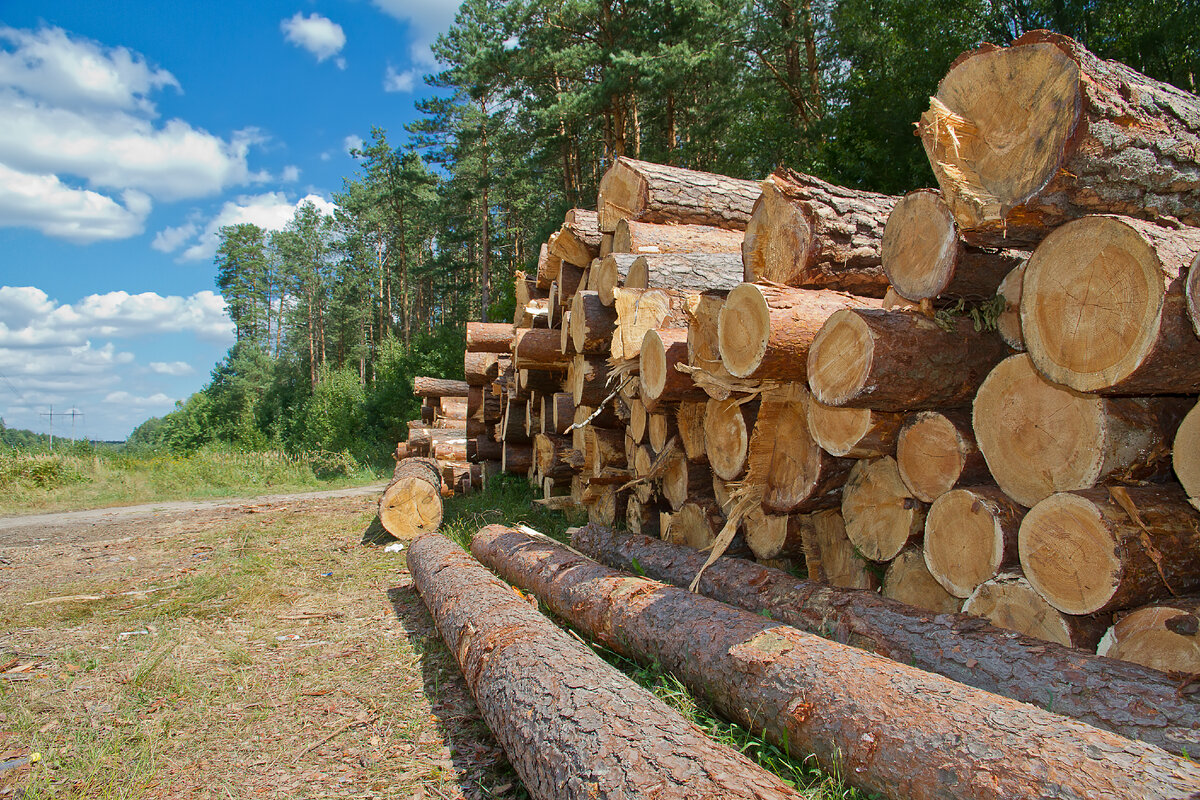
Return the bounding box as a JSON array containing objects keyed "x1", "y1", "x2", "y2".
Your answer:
[{"x1": 718, "y1": 283, "x2": 878, "y2": 380}]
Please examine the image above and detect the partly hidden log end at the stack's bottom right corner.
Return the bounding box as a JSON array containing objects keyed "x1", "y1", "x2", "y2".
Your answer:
[{"x1": 1097, "y1": 595, "x2": 1200, "y2": 675}]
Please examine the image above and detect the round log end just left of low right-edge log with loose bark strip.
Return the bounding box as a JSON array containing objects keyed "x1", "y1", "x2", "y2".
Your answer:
[{"x1": 925, "y1": 486, "x2": 1026, "y2": 597}]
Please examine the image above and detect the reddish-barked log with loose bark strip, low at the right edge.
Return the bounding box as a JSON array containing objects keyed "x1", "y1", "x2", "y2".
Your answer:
[{"x1": 1018, "y1": 486, "x2": 1200, "y2": 614}]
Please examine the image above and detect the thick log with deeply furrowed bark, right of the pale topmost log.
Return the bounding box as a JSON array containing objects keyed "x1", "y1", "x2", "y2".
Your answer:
[{"x1": 742, "y1": 169, "x2": 899, "y2": 297}]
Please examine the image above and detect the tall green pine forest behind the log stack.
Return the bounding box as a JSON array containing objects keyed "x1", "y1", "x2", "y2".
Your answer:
[{"x1": 130, "y1": 0, "x2": 1200, "y2": 463}]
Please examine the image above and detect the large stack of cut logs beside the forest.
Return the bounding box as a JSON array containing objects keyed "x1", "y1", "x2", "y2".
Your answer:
[{"x1": 467, "y1": 32, "x2": 1200, "y2": 672}]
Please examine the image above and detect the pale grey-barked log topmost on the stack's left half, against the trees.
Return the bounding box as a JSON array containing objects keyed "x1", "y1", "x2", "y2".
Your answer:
[{"x1": 596, "y1": 156, "x2": 761, "y2": 231}]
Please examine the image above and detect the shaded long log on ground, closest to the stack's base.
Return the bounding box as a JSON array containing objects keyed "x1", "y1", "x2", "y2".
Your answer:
[{"x1": 571, "y1": 525, "x2": 1200, "y2": 753}]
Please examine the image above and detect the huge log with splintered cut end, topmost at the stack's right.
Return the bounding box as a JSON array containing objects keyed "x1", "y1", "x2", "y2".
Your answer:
[{"x1": 918, "y1": 31, "x2": 1200, "y2": 247}]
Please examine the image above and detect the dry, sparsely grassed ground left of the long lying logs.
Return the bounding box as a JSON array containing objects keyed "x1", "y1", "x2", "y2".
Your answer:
[{"x1": 0, "y1": 495, "x2": 523, "y2": 800}]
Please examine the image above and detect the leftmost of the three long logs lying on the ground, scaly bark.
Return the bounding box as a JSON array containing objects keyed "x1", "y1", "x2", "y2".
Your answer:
[{"x1": 408, "y1": 536, "x2": 800, "y2": 800}]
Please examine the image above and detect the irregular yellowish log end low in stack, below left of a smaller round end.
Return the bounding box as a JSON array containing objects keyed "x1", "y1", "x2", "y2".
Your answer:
[{"x1": 841, "y1": 456, "x2": 926, "y2": 561}]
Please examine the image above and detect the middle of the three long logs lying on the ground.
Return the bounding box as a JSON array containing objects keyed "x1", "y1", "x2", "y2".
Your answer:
[{"x1": 472, "y1": 528, "x2": 1200, "y2": 800}]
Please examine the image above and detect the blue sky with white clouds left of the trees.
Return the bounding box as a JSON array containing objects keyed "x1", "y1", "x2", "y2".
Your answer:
[{"x1": 0, "y1": 0, "x2": 457, "y2": 439}]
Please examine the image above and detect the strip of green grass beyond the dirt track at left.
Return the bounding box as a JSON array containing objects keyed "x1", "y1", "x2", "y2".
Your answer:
[{"x1": 0, "y1": 449, "x2": 383, "y2": 515}]
